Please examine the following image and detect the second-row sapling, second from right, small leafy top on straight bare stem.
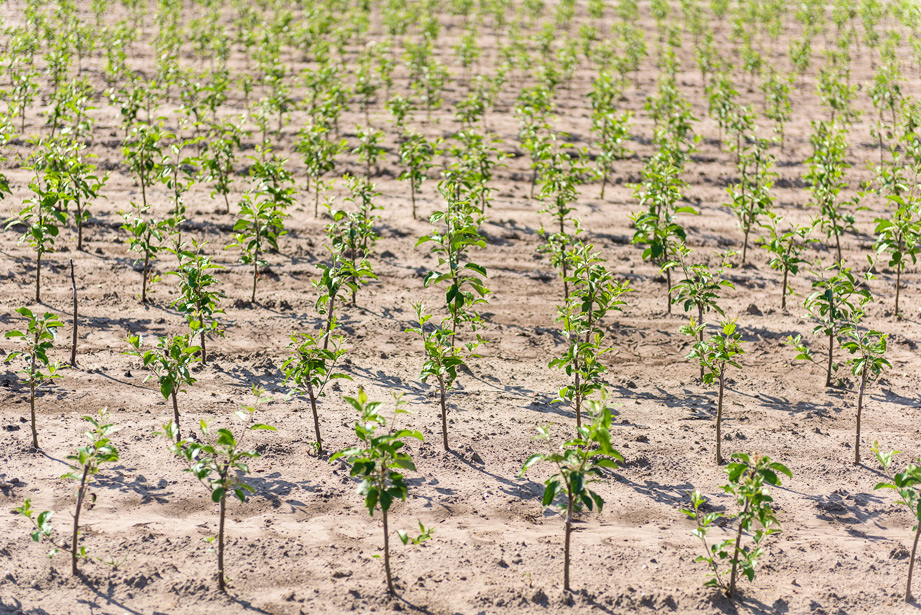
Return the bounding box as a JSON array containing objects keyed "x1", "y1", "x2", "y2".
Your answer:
[{"x1": 680, "y1": 317, "x2": 745, "y2": 465}]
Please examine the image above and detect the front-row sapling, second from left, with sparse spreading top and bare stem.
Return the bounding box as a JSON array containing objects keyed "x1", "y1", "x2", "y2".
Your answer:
[{"x1": 158, "y1": 387, "x2": 275, "y2": 592}]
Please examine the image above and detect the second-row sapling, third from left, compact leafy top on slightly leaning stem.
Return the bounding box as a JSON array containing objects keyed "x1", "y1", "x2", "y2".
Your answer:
[{"x1": 282, "y1": 331, "x2": 352, "y2": 455}]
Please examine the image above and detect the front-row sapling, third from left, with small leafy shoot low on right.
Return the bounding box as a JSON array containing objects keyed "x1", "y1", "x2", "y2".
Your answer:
[{"x1": 330, "y1": 389, "x2": 432, "y2": 594}]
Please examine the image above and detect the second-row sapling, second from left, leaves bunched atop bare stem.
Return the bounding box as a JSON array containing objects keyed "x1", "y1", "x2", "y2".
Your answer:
[{"x1": 125, "y1": 335, "x2": 201, "y2": 442}]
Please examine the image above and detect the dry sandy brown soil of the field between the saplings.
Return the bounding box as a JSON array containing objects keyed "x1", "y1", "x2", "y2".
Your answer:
[{"x1": 0, "y1": 3, "x2": 921, "y2": 615}]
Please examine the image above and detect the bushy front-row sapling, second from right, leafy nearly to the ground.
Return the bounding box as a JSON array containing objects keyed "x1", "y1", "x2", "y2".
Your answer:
[{"x1": 681, "y1": 453, "x2": 793, "y2": 599}]
